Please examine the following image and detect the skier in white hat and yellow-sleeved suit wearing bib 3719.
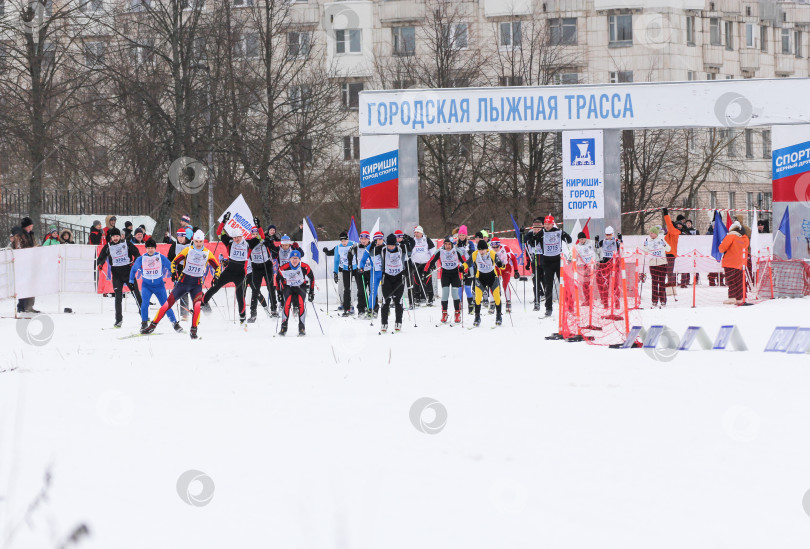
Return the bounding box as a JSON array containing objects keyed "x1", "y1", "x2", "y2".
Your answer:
[{"x1": 141, "y1": 229, "x2": 220, "y2": 339}]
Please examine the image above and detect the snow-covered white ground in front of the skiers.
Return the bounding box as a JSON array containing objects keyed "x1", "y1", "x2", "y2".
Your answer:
[{"x1": 0, "y1": 291, "x2": 810, "y2": 549}]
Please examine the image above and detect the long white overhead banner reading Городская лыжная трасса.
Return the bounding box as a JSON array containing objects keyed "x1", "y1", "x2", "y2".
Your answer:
[{"x1": 359, "y1": 78, "x2": 810, "y2": 136}]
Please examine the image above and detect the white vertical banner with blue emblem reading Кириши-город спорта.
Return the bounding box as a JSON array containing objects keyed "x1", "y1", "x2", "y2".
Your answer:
[{"x1": 562, "y1": 130, "x2": 605, "y2": 221}]
